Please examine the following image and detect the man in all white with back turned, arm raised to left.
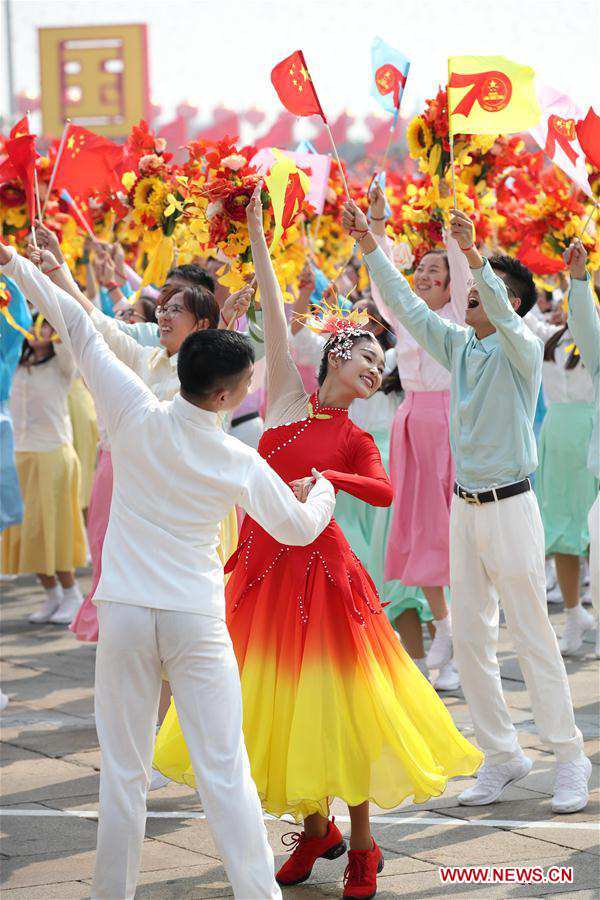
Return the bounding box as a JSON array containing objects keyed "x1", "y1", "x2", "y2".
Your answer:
[{"x1": 0, "y1": 245, "x2": 335, "y2": 900}]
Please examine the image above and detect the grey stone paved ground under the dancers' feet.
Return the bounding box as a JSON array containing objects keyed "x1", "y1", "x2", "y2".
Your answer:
[{"x1": 1, "y1": 577, "x2": 600, "y2": 900}]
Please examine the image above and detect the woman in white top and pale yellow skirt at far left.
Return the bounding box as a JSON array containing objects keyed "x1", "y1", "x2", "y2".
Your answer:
[{"x1": 2, "y1": 317, "x2": 86, "y2": 624}]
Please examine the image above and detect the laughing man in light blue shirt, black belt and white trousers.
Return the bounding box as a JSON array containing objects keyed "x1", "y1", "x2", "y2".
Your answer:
[{"x1": 343, "y1": 202, "x2": 592, "y2": 813}]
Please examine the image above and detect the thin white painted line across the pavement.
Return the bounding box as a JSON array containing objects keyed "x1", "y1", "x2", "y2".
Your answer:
[{"x1": 0, "y1": 807, "x2": 600, "y2": 831}]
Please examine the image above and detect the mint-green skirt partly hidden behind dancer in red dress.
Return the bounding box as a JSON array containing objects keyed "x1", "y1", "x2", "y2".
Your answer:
[{"x1": 335, "y1": 430, "x2": 433, "y2": 622}]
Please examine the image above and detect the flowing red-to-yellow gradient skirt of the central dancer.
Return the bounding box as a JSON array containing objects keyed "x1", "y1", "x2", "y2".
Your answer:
[{"x1": 154, "y1": 523, "x2": 482, "y2": 820}]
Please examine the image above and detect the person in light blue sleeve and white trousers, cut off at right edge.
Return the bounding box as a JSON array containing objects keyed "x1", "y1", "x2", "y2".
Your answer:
[{"x1": 565, "y1": 240, "x2": 600, "y2": 659}]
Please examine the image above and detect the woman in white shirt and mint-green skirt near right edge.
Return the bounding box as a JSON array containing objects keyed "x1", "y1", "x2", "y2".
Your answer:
[{"x1": 527, "y1": 317, "x2": 598, "y2": 656}]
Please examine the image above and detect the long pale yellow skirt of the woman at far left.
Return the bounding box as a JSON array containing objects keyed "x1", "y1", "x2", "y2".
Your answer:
[{"x1": 2, "y1": 444, "x2": 86, "y2": 575}]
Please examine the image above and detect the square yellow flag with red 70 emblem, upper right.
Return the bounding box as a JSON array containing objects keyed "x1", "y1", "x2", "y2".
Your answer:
[{"x1": 448, "y1": 56, "x2": 541, "y2": 134}]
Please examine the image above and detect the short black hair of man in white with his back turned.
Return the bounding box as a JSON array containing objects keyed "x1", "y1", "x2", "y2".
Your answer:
[{"x1": 177, "y1": 328, "x2": 254, "y2": 397}]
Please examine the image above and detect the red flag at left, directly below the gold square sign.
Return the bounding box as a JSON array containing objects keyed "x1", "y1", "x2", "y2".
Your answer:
[{"x1": 54, "y1": 125, "x2": 123, "y2": 199}]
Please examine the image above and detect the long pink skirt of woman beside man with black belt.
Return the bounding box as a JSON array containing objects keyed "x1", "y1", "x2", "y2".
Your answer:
[{"x1": 385, "y1": 391, "x2": 454, "y2": 587}]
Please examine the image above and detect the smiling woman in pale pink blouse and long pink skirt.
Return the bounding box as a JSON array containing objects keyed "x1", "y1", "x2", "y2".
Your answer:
[{"x1": 369, "y1": 187, "x2": 470, "y2": 669}]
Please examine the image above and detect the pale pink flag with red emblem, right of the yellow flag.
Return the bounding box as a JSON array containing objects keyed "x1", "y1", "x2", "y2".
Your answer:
[{"x1": 530, "y1": 85, "x2": 593, "y2": 197}]
